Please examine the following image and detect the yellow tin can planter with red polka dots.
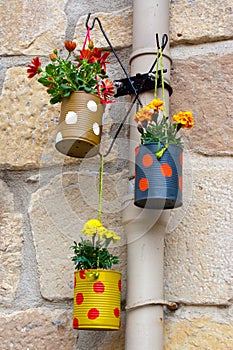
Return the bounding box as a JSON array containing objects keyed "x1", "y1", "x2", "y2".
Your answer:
[{"x1": 73, "y1": 269, "x2": 121, "y2": 330}]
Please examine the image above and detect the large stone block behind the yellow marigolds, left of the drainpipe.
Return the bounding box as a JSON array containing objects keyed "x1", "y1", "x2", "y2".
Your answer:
[{"x1": 29, "y1": 172, "x2": 126, "y2": 300}]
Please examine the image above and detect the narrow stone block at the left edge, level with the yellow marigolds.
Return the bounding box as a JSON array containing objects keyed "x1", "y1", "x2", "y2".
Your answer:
[{"x1": 0, "y1": 180, "x2": 23, "y2": 306}]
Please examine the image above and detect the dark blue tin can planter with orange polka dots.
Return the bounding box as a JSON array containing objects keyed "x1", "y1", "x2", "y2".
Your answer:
[{"x1": 134, "y1": 142, "x2": 183, "y2": 209}]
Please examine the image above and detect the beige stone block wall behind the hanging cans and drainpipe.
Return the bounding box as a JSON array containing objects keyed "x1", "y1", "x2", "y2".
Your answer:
[{"x1": 0, "y1": 0, "x2": 233, "y2": 350}]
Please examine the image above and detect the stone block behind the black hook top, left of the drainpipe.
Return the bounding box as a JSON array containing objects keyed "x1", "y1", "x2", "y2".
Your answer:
[{"x1": 74, "y1": 7, "x2": 133, "y2": 49}]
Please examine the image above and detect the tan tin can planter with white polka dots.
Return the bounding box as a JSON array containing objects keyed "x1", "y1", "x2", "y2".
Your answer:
[{"x1": 55, "y1": 91, "x2": 104, "y2": 158}]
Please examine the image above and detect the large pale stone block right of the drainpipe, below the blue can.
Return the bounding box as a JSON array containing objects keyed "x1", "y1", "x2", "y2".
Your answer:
[{"x1": 165, "y1": 155, "x2": 233, "y2": 305}]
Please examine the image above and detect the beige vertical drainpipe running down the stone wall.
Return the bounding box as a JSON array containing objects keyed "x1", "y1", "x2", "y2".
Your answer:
[{"x1": 123, "y1": 0, "x2": 171, "y2": 350}]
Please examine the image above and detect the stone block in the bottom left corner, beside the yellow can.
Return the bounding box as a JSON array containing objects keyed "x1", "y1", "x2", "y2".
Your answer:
[{"x1": 0, "y1": 308, "x2": 76, "y2": 350}]
